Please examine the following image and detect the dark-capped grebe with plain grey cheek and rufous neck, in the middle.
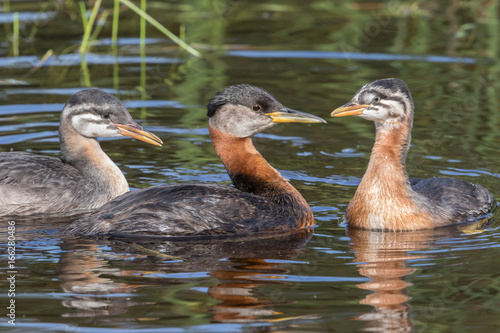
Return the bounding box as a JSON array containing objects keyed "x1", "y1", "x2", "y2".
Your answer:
[{"x1": 66, "y1": 84, "x2": 325, "y2": 236}]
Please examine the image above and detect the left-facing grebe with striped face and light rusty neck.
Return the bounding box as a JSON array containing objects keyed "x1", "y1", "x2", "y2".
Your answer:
[{"x1": 332, "y1": 79, "x2": 495, "y2": 230}]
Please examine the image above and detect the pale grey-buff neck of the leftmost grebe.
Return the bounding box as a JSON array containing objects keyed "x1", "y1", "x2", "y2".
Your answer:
[{"x1": 59, "y1": 119, "x2": 129, "y2": 198}]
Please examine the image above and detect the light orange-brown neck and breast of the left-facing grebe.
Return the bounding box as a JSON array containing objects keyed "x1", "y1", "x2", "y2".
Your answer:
[{"x1": 346, "y1": 123, "x2": 432, "y2": 230}]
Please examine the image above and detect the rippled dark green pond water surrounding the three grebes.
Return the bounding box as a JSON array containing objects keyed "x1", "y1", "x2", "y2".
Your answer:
[{"x1": 0, "y1": 0, "x2": 500, "y2": 332}]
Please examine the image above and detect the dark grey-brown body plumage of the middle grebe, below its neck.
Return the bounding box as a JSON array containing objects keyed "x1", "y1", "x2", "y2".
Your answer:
[{"x1": 68, "y1": 184, "x2": 300, "y2": 236}]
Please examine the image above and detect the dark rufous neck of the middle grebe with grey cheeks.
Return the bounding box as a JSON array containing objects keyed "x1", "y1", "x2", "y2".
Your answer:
[{"x1": 209, "y1": 128, "x2": 314, "y2": 227}]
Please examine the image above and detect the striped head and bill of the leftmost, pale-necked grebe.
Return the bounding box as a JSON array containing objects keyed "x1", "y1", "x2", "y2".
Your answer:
[{"x1": 61, "y1": 89, "x2": 163, "y2": 146}]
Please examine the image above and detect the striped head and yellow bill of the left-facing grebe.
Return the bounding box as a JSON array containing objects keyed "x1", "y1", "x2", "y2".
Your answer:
[{"x1": 331, "y1": 79, "x2": 413, "y2": 124}]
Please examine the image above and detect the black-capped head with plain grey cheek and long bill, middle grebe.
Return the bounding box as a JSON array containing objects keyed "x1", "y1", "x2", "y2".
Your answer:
[{"x1": 207, "y1": 84, "x2": 326, "y2": 138}]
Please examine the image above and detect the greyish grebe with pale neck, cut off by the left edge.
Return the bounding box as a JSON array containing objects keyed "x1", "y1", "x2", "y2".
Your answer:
[{"x1": 0, "y1": 89, "x2": 162, "y2": 215}]
